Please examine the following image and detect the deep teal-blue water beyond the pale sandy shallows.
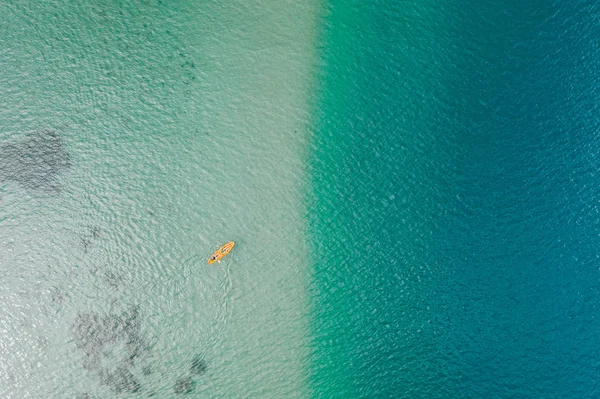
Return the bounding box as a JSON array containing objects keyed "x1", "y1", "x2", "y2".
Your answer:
[{"x1": 309, "y1": 0, "x2": 600, "y2": 398}]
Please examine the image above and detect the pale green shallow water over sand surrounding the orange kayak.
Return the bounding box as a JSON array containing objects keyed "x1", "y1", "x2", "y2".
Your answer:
[{"x1": 0, "y1": 1, "x2": 315, "y2": 398}]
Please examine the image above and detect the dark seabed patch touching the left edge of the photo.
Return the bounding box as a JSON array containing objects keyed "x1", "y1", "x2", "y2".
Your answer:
[{"x1": 0, "y1": 129, "x2": 71, "y2": 194}]
